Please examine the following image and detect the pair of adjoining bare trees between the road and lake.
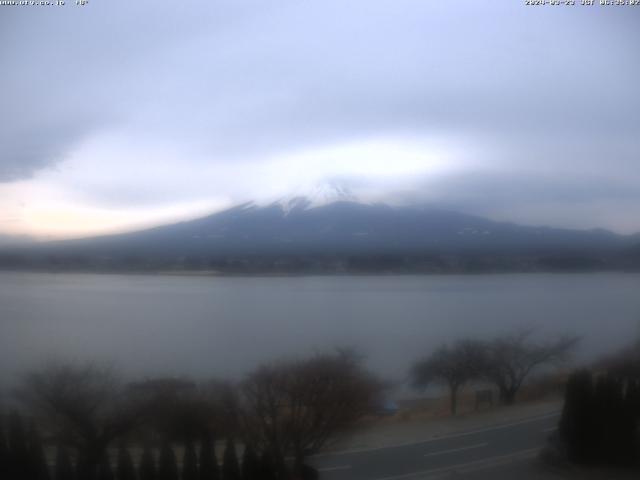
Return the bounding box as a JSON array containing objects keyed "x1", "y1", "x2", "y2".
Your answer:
[{"x1": 410, "y1": 329, "x2": 578, "y2": 415}]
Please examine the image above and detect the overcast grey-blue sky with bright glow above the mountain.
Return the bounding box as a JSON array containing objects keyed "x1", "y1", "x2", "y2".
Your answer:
[{"x1": 0, "y1": 0, "x2": 640, "y2": 237}]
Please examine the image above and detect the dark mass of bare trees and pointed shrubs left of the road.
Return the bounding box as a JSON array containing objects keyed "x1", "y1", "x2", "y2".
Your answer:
[{"x1": 0, "y1": 350, "x2": 383, "y2": 480}]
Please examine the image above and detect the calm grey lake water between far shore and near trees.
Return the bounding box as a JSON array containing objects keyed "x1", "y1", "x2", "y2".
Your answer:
[{"x1": 0, "y1": 273, "x2": 640, "y2": 388}]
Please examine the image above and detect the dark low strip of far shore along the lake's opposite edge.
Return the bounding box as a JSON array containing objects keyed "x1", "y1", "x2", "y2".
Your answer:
[{"x1": 0, "y1": 249, "x2": 640, "y2": 275}]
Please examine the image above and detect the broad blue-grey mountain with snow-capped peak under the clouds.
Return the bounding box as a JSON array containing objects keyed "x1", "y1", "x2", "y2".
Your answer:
[{"x1": 0, "y1": 185, "x2": 640, "y2": 271}]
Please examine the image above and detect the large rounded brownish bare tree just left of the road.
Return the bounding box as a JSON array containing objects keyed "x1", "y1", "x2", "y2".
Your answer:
[{"x1": 240, "y1": 351, "x2": 381, "y2": 472}]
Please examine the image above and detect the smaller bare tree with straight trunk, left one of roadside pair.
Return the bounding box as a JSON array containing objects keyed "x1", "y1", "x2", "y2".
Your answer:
[{"x1": 411, "y1": 340, "x2": 483, "y2": 415}]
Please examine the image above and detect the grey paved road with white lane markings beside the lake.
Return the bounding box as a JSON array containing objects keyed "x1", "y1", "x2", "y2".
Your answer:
[{"x1": 311, "y1": 413, "x2": 559, "y2": 480}]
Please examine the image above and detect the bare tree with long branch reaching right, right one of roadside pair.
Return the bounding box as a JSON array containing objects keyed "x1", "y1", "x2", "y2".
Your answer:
[{"x1": 481, "y1": 329, "x2": 579, "y2": 405}]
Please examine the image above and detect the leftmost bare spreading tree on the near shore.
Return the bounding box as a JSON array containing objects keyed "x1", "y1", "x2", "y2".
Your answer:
[{"x1": 18, "y1": 364, "x2": 148, "y2": 480}]
